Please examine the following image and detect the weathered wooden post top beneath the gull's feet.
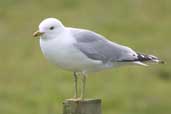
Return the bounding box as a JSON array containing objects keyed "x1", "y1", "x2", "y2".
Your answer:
[{"x1": 63, "y1": 99, "x2": 101, "y2": 114}]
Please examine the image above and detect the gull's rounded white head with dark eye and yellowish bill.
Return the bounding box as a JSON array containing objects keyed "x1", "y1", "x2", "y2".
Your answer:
[{"x1": 33, "y1": 18, "x2": 64, "y2": 38}]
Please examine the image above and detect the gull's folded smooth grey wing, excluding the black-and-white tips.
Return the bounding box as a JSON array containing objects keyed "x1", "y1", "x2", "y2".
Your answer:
[{"x1": 69, "y1": 28, "x2": 136, "y2": 62}]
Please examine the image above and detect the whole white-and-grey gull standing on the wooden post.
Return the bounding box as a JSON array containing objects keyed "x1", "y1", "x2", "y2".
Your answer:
[{"x1": 33, "y1": 18, "x2": 164, "y2": 100}]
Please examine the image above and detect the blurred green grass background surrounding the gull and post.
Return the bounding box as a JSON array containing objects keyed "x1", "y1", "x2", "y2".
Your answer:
[{"x1": 0, "y1": 0, "x2": 171, "y2": 114}]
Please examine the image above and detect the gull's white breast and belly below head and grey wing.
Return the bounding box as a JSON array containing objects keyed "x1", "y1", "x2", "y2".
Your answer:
[{"x1": 40, "y1": 40, "x2": 106, "y2": 72}]
